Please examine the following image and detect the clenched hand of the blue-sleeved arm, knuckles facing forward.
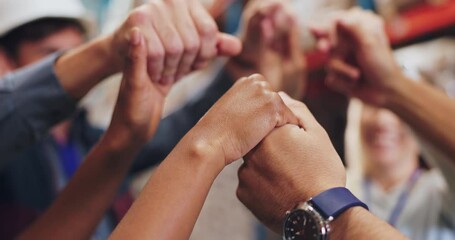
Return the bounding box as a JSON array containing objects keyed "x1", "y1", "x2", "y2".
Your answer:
[{"x1": 111, "y1": 0, "x2": 241, "y2": 85}]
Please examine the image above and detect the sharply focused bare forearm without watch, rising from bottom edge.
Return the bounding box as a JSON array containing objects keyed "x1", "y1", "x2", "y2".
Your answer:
[{"x1": 111, "y1": 133, "x2": 224, "y2": 240}]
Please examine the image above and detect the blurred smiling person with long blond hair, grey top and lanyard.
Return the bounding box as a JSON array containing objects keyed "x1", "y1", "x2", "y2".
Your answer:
[{"x1": 346, "y1": 100, "x2": 455, "y2": 239}]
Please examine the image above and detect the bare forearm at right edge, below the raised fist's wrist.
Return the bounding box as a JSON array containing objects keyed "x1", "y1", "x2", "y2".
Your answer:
[{"x1": 386, "y1": 75, "x2": 455, "y2": 161}]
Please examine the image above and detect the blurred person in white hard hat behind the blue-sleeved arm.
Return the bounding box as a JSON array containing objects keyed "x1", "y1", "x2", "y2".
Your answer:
[{"x1": 0, "y1": 1, "x2": 101, "y2": 238}]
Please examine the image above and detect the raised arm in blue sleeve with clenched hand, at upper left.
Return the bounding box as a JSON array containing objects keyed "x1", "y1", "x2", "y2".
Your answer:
[{"x1": 0, "y1": 0, "x2": 241, "y2": 166}]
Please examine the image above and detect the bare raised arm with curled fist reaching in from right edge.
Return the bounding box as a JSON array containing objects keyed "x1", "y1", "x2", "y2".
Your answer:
[{"x1": 318, "y1": 9, "x2": 455, "y2": 164}]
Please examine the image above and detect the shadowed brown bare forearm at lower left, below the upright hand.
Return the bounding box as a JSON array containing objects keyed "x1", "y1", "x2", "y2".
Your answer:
[{"x1": 19, "y1": 131, "x2": 139, "y2": 239}]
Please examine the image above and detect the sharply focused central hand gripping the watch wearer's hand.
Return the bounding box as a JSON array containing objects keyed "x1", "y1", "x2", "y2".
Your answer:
[{"x1": 190, "y1": 74, "x2": 299, "y2": 167}]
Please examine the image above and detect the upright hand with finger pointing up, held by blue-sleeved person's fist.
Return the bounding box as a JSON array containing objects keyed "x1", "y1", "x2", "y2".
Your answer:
[{"x1": 106, "y1": 28, "x2": 172, "y2": 147}]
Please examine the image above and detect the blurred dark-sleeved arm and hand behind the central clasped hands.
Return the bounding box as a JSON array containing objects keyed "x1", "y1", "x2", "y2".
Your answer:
[{"x1": 133, "y1": 0, "x2": 306, "y2": 171}]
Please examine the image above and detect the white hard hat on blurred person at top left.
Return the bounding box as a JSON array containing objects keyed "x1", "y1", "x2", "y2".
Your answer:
[{"x1": 0, "y1": 0, "x2": 92, "y2": 37}]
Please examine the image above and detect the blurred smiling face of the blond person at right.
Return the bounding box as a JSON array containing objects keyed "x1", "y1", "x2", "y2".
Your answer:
[{"x1": 361, "y1": 105, "x2": 419, "y2": 169}]
